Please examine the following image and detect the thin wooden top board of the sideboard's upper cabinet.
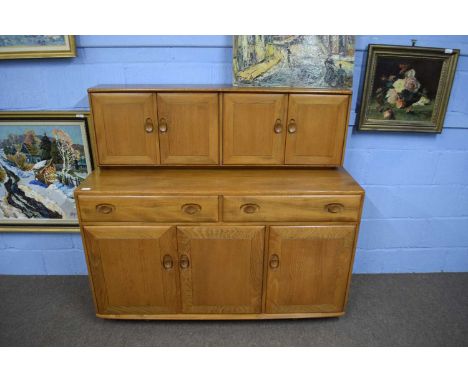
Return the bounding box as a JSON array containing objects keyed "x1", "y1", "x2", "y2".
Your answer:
[{"x1": 88, "y1": 84, "x2": 352, "y2": 94}]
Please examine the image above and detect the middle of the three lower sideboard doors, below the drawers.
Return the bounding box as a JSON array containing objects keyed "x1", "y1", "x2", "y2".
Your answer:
[{"x1": 177, "y1": 226, "x2": 264, "y2": 313}]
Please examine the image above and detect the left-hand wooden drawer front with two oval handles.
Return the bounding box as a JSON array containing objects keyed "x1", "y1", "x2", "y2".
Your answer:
[{"x1": 78, "y1": 195, "x2": 218, "y2": 222}]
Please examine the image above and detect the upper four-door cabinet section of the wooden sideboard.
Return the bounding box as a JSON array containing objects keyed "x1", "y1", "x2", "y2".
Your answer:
[{"x1": 89, "y1": 87, "x2": 351, "y2": 166}]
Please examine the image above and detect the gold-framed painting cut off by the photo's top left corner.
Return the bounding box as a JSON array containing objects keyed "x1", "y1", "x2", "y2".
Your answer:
[{"x1": 0, "y1": 35, "x2": 76, "y2": 59}]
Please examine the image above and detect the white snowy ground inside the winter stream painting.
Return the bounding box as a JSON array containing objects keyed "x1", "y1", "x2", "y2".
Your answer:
[{"x1": 0, "y1": 150, "x2": 76, "y2": 220}]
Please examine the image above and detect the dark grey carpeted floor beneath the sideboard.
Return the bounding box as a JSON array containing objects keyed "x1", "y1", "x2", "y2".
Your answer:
[{"x1": 0, "y1": 273, "x2": 468, "y2": 346}]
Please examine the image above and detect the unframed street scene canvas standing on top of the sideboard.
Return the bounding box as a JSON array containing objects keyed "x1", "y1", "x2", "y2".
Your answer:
[{"x1": 233, "y1": 35, "x2": 354, "y2": 89}]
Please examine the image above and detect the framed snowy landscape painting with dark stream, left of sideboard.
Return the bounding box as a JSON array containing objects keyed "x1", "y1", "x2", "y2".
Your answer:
[{"x1": 0, "y1": 112, "x2": 93, "y2": 231}]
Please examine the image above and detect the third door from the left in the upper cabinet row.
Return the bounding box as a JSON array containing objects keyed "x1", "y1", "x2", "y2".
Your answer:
[{"x1": 223, "y1": 94, "x2": 287, "y2": 165}]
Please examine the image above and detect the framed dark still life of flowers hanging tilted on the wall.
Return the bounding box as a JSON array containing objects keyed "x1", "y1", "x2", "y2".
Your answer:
[{"x1": 358, "y1": 45, "x2": 460, "y2": 133}]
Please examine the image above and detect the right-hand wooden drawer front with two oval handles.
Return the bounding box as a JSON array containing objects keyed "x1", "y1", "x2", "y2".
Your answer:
[{"x1": 223, "y1": 195, "x2": 361, "y2": 222}]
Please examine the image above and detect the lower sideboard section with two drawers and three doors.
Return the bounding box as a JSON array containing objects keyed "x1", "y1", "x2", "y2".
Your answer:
[{"x1": 76, "y1": 169, "x2": 364, "y2": 319}]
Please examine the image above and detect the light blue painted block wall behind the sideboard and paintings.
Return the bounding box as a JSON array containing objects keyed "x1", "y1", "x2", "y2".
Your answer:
[{"x1": 0, "y1": 36, "x2": 468, "y2": 274}]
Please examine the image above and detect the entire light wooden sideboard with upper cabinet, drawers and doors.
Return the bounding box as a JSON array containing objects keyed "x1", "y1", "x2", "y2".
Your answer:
[{"x1": 75, "y1": 86, "x2": 364, "y2": 319}]
